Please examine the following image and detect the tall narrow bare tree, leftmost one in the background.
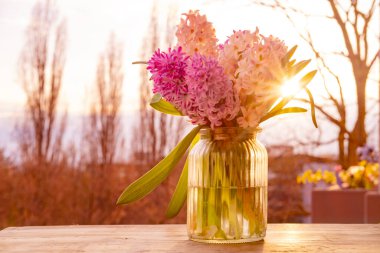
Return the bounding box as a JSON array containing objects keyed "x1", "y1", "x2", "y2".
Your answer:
[{"x1": 18, "y1": 0, "x2": 66, "y2": 164}]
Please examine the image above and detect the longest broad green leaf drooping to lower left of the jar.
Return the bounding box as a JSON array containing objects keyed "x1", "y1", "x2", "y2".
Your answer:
[{"x1": 117, "y1": 126, "x2": 201, "y2": 204}]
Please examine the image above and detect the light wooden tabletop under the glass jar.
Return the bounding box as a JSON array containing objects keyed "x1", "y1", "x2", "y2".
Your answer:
[{"x1": 0, "y1": 224, "x2": 380, "y2": 253}]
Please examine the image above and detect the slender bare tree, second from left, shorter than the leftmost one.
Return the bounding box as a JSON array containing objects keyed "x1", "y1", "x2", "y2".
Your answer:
[{"x1": 85, "y1": 34, "x2": 124, "y2": 167}]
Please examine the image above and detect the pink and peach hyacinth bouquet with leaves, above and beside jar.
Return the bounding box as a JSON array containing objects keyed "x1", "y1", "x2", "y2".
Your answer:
[{"x1": 118, "y1": 11, "x2": 316, "y2": 216}]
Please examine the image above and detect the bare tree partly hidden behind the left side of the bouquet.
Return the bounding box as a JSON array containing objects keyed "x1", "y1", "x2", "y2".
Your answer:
[{"x1": 132, "y1": 6, "x2": 184, "y2": 166}]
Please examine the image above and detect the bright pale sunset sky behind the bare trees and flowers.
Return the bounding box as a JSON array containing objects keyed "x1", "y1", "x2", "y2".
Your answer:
[{"x1": 0, "y1": 0, "x2": 379, "y2": 154}]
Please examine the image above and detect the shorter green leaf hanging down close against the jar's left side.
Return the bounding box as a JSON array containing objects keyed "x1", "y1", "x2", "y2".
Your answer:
[{"x1": 166, "y1": 134, "x2": 199, "y2": 218}]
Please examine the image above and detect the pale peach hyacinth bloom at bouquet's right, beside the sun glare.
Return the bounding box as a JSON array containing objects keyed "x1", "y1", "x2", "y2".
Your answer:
[{"x1": 235, "y1": 35, "x2": 287, "y2": 127}]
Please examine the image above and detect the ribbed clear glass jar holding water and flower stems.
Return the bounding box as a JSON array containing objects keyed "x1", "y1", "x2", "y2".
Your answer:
[{"x1": 187, "y1": 127, "x2": 268, "y2": 243}]
